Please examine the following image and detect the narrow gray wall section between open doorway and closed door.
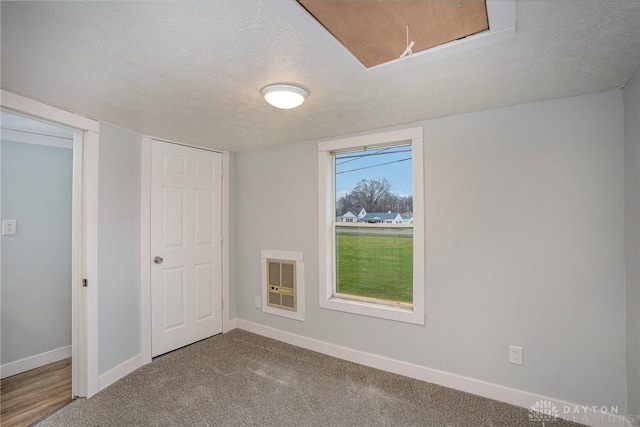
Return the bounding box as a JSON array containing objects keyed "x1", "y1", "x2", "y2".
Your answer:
[{"x1": 98, "y1": 123, "x2": 141, "y2": 374}]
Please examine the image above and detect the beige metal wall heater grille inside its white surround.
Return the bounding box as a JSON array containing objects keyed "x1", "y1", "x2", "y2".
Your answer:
[{"x1": 267, "y1": 259, "x2": 296, "y2": 311}]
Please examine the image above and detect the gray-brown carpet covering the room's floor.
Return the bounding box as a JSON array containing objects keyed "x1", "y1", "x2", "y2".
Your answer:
[{"x1": 38, "y1": 330, "x2": 577, "y2": 427}]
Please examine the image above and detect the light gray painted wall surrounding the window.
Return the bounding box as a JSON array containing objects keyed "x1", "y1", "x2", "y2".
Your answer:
[{"x1": 232, "y1": 90, "x2": 627, "y2": 413}]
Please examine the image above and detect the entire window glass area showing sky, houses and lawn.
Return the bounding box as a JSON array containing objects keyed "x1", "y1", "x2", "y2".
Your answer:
[{"x1": 334, "y1": 145, "x2": 413, "y2": 303}]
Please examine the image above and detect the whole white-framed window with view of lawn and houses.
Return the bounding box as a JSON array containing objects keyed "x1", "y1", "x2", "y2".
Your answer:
[{"x1": 318, "y1": 128, "x2": 424, "y2": 324}]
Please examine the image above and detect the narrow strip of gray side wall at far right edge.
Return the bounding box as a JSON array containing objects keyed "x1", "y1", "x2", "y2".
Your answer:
[{"x1": 624, "y1": 66, "x2": 640, "y2": 426}]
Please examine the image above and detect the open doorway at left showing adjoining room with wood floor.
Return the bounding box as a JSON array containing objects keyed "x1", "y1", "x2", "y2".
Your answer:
[{"x1": 0, "y1": 111, "x2": 74, "y2": 426}]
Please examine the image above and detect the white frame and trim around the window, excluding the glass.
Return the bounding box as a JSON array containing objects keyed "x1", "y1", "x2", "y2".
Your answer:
[{"x1": 318, "y1": 127, "x2": 425, "y2": 325}]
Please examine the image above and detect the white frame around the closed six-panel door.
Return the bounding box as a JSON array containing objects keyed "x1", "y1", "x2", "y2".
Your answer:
[{"x1": 140, "y1": 135, "x2": 235, "y2": 365}]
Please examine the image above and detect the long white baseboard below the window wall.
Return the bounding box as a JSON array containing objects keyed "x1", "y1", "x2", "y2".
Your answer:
[{"x1": 236, "y1": 319, "x2": 628, "y2": 427}]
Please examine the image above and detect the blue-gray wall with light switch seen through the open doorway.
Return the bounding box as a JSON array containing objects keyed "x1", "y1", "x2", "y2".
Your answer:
[{"x1": 0, "y1": 141, "x2": 73, "y2": 364}]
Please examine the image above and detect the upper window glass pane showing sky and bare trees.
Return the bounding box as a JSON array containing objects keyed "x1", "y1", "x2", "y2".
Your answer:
[{"x1": 334, "y1": 145, "x2": 413, "y2": 224}]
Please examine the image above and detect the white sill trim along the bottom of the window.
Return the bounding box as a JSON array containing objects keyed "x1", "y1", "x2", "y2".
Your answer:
[{"x1": 320, "y1": 297, "x2": 425, "y2": 325}]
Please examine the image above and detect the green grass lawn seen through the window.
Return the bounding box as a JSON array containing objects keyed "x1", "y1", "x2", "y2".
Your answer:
[{"x1": 336, "y1": 234, "x2": 413, "y2": 302}]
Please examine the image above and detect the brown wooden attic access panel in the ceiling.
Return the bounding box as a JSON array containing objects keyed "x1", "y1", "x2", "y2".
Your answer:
[{"x1": 297, "y1": 0, "x2": 489, "y2": 68}]
